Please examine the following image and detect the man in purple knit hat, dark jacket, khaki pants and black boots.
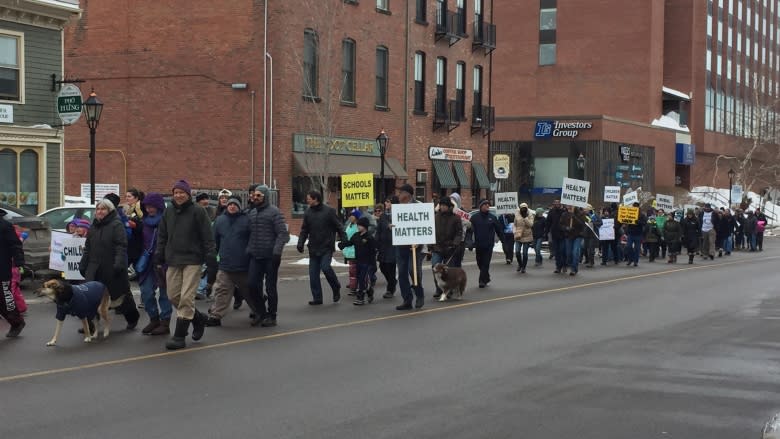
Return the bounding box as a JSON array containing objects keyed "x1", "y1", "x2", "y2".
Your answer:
[{"x1": 155, "y1": 180, "x2": 217, "y2": 349}]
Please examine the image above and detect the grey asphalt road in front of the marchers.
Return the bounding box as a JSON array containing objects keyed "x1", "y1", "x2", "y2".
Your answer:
[{"x1": 0, "y1": 240, "x2": 780, "y2": 439}]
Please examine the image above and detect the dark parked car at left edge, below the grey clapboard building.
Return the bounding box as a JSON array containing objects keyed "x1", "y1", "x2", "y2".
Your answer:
[{"x1": 0, "y1": 204, "x2": 51, "y2": 271}]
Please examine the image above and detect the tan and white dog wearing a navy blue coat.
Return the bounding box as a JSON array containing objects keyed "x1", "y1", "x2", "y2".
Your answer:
[{"x1": 36, "y1": 279, "x2": 111, "y2": 346}]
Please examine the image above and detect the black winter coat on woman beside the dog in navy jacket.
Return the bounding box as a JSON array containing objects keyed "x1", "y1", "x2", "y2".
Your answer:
[{"x1": 79, "y1": 210, "x2": 130, "y2": 300}]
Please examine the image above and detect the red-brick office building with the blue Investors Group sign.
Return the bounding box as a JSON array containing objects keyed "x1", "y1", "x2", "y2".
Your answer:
[{"x1": 490, "y1": 0, "x2": 780, "y2": 210}]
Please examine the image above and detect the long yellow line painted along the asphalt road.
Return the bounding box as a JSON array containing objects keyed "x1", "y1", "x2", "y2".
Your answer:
[{"x1": 0, "y1": 256, "x2": 780, "y2": 383}]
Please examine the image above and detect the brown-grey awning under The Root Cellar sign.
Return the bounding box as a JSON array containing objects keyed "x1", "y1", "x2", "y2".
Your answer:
[{"x1": 293, "y1": 152, "x2": 409, "y2": 179}]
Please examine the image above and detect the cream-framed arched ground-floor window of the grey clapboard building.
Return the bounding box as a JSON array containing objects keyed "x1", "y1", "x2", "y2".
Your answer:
[{"x1": 0, "y1": 148, "x2": 40, "y2": 213}]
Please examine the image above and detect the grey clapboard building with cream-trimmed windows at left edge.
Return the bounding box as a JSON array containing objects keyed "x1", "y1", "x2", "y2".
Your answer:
[{"x1": 0, "y1": 0, "x2": 81, "y2": 213}]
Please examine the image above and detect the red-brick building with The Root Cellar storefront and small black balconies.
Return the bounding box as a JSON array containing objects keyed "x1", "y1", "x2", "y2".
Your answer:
[{"x1": 65, "y1": 0, "x2": 495, "y2": 227}]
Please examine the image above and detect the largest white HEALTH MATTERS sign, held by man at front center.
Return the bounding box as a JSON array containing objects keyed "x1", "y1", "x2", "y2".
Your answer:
[{"x1": 391, "y1": 203, "x2": 436, "y2": 245}]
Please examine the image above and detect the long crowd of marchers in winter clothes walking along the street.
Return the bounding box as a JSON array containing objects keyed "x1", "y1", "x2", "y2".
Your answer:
[{"x1": 0, "y1": 180, "x2": 767, "y2": 350}]
